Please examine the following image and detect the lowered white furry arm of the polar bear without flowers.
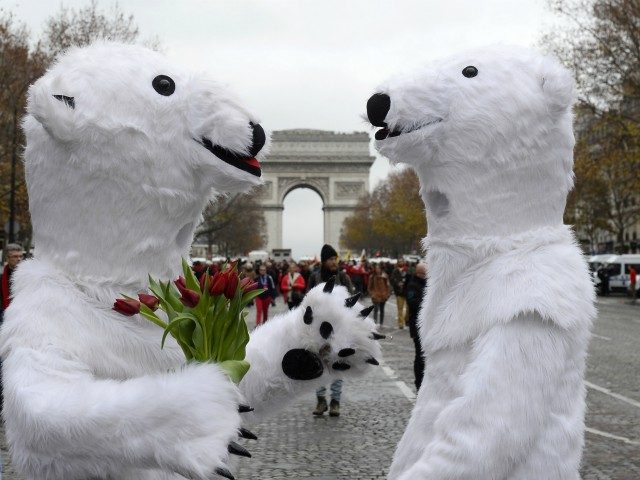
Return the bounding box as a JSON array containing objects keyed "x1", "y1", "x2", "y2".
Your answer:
[{"x1": 398, "y1": 313, "x2": 571, "y2": 480}]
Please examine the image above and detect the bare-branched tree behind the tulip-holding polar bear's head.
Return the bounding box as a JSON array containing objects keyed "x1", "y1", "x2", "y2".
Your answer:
[{"x1": 0, "y1": 0, "x2": 159, "y2": 251}]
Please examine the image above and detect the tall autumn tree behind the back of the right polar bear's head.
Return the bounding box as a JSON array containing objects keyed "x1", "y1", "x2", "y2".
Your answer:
[{"x1": 543, "y1": 0, "x2": 640, "y2": 251}]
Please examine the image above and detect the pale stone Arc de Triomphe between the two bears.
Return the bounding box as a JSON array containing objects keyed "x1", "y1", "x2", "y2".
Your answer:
[{"x1": 260, "y1": 129, "x2": 374, "y2": 252}]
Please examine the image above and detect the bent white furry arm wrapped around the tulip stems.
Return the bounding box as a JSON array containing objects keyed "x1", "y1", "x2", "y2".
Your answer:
[{"x1": 2, "y1": 347, "x2": 241, "y2": 480}]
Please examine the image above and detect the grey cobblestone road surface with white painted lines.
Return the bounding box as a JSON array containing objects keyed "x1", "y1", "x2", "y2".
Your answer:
[{"x1": 2, "y1": 297, "x2": 640, "y2": 480}]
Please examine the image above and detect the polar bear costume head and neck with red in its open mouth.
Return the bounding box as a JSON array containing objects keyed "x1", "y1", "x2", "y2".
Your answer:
[{"x1": 24, "y1": 43, "x2": 267, "y2": 292}]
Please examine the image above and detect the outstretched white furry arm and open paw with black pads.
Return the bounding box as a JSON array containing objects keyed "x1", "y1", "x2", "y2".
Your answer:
[{"x1": 239, "y1": 284, "x2": 381, "y2": 420}]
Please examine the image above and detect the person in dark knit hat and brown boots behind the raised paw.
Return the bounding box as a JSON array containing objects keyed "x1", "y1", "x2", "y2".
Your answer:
[{"x1": 308, "y1": 245, "x2": 353, "y2": 417}]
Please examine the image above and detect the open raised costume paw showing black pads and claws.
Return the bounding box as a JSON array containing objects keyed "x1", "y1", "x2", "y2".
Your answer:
[{"x1": 282, "y1": 277, "x2": 384, "y2": 380}]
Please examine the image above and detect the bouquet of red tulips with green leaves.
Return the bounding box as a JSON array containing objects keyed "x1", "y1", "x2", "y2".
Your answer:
[{"x1": 113, "y1": 259, "x2": 264, "y2": 383}]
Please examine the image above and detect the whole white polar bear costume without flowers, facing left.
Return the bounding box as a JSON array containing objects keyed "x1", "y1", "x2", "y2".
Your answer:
[{"x1": 367, "y1": 47, "x2": 595, "y2": 480}]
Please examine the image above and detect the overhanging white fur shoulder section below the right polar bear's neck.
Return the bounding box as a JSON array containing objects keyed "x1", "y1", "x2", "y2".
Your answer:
[{"x1": 421, "y1": 226, "x2": 596, "y2": 348}]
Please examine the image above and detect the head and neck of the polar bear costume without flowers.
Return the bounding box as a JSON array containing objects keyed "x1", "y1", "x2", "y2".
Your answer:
[{"x1": 368, "y1": 46, "x2": 574, "y2": 239}]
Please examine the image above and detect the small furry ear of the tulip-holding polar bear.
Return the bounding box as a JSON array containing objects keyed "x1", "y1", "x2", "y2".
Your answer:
[{"x1": 27, "y1": 80, "x2": 77, "y2": 142}]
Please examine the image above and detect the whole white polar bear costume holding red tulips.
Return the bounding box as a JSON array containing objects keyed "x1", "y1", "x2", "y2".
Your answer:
[{"x1": 0, "y1": 43, "x2": 380, "y2": 480}]
